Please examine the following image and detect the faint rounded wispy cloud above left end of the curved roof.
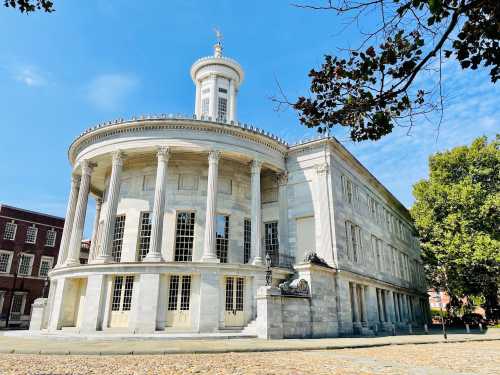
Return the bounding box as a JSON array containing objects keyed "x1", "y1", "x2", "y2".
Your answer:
[{"x1": 86, "y1": 73, "x2": 139, "y2": 110}]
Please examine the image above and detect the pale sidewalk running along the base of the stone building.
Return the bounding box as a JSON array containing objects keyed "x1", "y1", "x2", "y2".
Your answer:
[{"x1": 0, "y1": 328, "x2": 500, "y2": 355}]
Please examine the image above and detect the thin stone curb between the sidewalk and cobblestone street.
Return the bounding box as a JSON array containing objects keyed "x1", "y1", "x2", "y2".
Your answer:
[{"x1": 0, "y1": 338, "x2": 500, "y2": 356}]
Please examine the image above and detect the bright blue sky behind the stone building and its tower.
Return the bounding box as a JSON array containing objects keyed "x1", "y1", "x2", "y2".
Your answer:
[{"x1": 0, "y1": 0, "x2": 500, "y2": 236}]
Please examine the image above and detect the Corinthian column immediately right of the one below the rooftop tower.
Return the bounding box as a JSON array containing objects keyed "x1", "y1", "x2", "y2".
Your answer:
[{"x1": 250, "y1": 160, "x2": 263, "y2": 265}]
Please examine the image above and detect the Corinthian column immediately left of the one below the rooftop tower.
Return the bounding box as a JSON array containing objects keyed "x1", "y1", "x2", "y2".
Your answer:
[{"x1": 144, "y1": 147, "x2": 170, "y2": 262}]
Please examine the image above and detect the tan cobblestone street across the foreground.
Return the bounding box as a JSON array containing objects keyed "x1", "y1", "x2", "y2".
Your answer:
[{"x1": 0, "y1": 341, "x2": 500, "y2": 375}]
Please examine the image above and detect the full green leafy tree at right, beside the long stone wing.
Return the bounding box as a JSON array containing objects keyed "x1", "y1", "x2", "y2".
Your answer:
[{"x1": 410, "y1": 135, "x2": 500, "y2": 319}]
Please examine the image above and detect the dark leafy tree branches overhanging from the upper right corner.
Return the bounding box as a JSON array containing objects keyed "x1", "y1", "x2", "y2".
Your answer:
[{"x1": 292, "y1": 0, "x2": 500, "y2": 141}]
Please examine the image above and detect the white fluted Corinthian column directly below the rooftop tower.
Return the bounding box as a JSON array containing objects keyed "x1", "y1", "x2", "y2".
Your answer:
[{"x1": 201, "y1": 151, "x2": 220, "y2": 263}]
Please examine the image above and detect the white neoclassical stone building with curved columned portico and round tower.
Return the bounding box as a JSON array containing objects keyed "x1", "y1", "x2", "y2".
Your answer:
[{"x1": 32, "y1": 44, "x2": 427, "y2": 338}]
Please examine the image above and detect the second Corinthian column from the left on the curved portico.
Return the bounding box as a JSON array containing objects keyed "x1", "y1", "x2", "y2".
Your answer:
[{"x1": 64, "y1": 160, "x2": 94, "y2": 266}]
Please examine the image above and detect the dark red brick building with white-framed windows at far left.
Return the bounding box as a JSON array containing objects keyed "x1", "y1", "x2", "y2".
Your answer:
[{"x1": 0, "y1": 205, "x2": 64, "y2": 327}]
